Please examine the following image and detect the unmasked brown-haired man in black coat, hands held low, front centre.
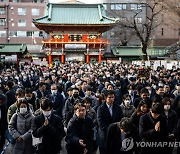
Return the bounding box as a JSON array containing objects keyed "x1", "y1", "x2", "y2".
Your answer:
[{"x1": 66, "y1": 103, "x2": 94, "y2": 154}]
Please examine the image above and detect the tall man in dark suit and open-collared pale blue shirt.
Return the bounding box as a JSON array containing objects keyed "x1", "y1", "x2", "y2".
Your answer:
[{"x1": 97, "y1": 90, "x2": 123, "y2": 154}]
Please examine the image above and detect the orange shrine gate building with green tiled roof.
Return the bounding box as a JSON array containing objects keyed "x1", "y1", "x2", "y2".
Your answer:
[{"x1": 33, "y1": 3, "x2": 116, "y2": 65}]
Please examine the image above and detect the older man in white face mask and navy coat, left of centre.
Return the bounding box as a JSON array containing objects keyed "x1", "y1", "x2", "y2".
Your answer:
[{"x1": 48, "y1": 84, "x2": 64, "y2": 118}]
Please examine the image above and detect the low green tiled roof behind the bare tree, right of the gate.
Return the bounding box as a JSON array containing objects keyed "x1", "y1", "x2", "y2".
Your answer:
[{"x1": 112, "y1": 46, "x2": 167, "y2": 56}]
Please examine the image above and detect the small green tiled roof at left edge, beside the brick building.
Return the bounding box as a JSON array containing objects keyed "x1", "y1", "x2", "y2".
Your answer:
[{"x1": 0, "y1": 44, "x2": 27, "y2": 53}]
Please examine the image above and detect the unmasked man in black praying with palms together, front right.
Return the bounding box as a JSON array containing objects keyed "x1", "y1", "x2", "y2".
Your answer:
[{"x1": 139, "y1": 103, "x2": 168, "y2": 154}]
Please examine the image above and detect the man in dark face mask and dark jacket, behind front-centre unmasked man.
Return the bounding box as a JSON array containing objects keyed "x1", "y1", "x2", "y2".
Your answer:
[{"x1": 63, "y1": 88, "x2": 82, "y2": 127}]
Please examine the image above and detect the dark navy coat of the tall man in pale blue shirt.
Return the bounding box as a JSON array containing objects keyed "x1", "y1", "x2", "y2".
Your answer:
[{"x1": 97, "y1": 103, "x2": 123, "y2": 147}]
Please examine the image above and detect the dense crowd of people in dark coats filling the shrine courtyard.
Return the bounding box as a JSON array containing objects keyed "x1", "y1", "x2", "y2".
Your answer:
[{"x1": 0, "y1": 62, "x2": 180, "y2": 154}]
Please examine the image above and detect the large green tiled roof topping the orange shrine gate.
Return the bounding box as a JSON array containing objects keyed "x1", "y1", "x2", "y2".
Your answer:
[{"x1": 33, "y1": 3, "x2": 115, "y2": 25}]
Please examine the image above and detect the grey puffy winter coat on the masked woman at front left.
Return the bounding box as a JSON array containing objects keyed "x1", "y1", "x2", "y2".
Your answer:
[{"x1": 8, "y1": 112, "x2": 33, "y2": 154}]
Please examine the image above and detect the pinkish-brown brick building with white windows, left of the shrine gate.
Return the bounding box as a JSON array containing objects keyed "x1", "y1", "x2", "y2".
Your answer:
[{"x1": 0, "y1": 0, "x2": 46, "y2": 56}]
